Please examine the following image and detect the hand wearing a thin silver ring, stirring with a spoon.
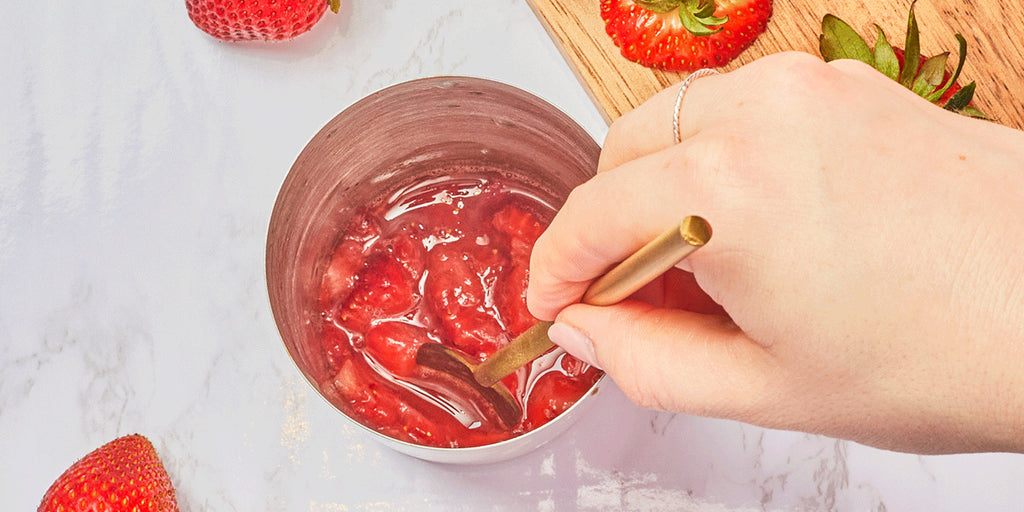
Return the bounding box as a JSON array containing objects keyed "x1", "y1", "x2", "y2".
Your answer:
[{"x1": 527, "y1": 53, "x2": 1024, "y2": 454}]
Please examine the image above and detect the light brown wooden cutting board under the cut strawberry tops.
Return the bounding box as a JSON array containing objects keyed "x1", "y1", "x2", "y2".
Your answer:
[{"x1": 529, "y1": 0, "x2": 1024, "y2": 128}]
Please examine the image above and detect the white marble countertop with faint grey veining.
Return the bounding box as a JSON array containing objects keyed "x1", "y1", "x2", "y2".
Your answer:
[{"x1": 0, "y1": 0, "x2": 1024, "y2": 512}]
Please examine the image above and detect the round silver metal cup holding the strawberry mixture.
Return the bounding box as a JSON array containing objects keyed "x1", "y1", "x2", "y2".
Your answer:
[{"x1": 266, "y1": 77, "x2": 601, "y2": 463}]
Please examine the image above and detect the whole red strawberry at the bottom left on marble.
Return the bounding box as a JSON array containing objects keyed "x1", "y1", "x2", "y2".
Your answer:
[{"x1": 39, "y1": 434, "x2": 178, "y2": 512}]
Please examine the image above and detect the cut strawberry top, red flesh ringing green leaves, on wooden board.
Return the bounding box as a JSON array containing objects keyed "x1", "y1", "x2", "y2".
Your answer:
[{"x1": 601, "y1": 0, "x2": 772, "y2": 72}]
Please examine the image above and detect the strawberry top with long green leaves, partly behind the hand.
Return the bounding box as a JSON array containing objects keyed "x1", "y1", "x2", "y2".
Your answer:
[{"x1": 818, "y1": 3, "x2": 986, "y2": 119}]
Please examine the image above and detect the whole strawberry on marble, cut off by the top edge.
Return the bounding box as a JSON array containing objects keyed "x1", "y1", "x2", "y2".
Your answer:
[{"x1": 185, "y1": 0, "x2": 341, "y2": 41}]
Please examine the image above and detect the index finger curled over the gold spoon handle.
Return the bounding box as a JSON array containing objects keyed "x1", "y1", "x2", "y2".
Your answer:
[{"x1": 526, "y1": 140, "x2": 716, "y2": 319}]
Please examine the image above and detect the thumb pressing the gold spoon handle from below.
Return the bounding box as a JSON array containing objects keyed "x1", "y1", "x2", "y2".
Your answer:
[{"x1": 548, "y1": 301, "x2": 774, "y2": 422}]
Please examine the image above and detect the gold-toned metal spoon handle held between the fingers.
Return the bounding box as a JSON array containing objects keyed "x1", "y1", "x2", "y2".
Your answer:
[{"x1": 473, "y1": 215, "x2": 711, "y2": 387}]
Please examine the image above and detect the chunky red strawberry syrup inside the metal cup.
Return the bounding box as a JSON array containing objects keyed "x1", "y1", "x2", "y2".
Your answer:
[{"x1": 317, "y1": 169, "x2": 600, "y2": 447}]
